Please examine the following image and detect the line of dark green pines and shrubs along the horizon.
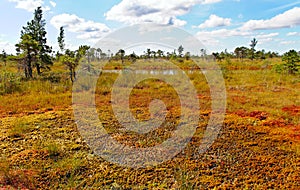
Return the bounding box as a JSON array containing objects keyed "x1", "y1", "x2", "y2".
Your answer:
[{"x1": 0, "y1": 7, "x2": 300, "y2": 82}]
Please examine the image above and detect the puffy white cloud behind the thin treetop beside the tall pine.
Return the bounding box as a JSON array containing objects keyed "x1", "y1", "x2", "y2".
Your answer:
[{"x1": 50, "y1": 14, "x2": 110, "y2": 39}]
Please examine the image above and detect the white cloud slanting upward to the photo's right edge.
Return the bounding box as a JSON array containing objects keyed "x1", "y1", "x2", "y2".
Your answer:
[{"x1": 241, "y1": 7, "x2": 300, "y2": 30}]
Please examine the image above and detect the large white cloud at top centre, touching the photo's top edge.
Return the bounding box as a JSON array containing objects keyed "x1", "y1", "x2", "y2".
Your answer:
[{"x1": 105, "y1": 0, "x2": 222, "y2": 26}]
